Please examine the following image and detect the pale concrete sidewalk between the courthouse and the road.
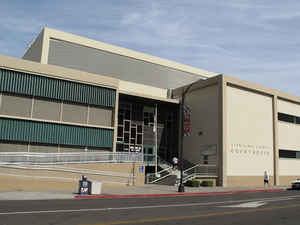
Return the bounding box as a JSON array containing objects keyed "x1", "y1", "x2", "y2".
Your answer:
[{"x1": 0, "y1": 184, "x2": 288, "y2": 200}]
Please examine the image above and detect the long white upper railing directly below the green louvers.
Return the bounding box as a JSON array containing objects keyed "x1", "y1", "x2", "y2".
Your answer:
[{"x1": 0, "y1": 152, "x2": 144, "y2": 164}]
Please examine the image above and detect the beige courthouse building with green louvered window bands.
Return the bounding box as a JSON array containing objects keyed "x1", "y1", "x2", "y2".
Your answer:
[{"x1": 0, "y1": 28, "x2": 300, "y2": 186}]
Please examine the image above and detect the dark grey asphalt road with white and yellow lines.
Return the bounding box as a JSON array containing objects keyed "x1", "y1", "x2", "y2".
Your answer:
[{"x1": 0, "y1": 191, "x2": 300, "y2": 225}]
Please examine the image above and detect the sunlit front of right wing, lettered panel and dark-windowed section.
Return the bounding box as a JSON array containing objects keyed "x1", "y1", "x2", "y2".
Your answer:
[{"x1": 174, "y1": 75, "x2": 300, "y2": 186}]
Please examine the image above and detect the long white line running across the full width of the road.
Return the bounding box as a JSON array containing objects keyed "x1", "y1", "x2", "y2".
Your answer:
[{"x1": 0, "y1": 195, "x2": 300, "y2": 215}]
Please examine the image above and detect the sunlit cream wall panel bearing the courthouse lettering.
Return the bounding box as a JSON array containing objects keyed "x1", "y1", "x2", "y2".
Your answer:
[{"x1": 225, "y1": 86, "x2": 273, "y2": 177}]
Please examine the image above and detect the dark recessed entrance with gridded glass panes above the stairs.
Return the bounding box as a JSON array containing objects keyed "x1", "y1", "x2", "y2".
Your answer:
[{"x1": 117, "y1": 94, "x2": 179, "y2": 162}]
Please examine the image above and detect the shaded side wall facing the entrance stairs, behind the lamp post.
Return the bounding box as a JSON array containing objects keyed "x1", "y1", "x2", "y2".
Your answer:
[{"x1": 184, "y1": 85, "x2": 219, "y2": 164}]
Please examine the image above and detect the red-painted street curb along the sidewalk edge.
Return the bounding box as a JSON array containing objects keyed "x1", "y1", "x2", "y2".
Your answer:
[{"x1": 74, "y1": 188, "x2": 285, "y2": 199}]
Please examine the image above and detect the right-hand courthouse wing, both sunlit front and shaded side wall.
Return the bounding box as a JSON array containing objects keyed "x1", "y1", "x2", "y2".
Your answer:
[{"x1": 174, "y1": 75, "x2": 300, "y2": 186}]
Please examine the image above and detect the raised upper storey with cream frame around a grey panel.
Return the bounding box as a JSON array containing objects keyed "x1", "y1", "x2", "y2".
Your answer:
[{"x1": 23, "y1": 28, "x2": 214, "y2": 89}]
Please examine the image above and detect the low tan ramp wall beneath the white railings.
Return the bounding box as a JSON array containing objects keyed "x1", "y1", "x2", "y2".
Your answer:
[{"x1": 0, "y1": 163, "x2": 145, "y2": 192}]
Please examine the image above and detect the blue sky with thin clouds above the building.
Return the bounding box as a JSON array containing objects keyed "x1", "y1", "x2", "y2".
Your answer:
[{"x1": 0, "y1": 0, "x2": 300, "y2": 96}]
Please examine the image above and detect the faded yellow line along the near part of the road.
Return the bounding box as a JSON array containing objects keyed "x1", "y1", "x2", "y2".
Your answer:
[{"x1": 89, "y1": 204, "x2": 300, "y2": 225}]
